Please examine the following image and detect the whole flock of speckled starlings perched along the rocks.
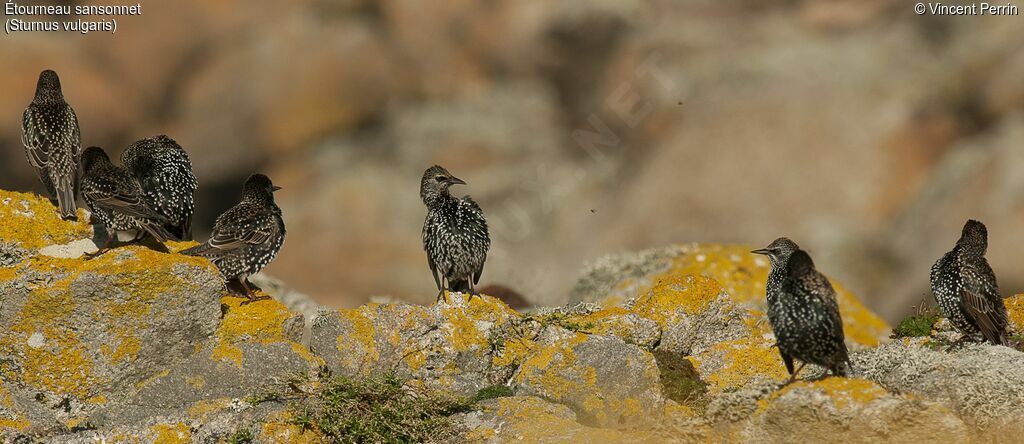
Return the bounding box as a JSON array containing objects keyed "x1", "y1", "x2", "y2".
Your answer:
[{"x1": 12, "y1": 70, "x2": 1009, "y2": 381}]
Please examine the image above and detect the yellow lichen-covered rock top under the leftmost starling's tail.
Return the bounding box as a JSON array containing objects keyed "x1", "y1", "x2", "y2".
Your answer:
[{"x1": 0, "y1": 190, "x2": 92, "y2": 250}]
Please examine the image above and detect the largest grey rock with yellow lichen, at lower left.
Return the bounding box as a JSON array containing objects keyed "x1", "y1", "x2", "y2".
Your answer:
[{"x1": 0, "y1": 247, "x2": 223, "y2": 420}]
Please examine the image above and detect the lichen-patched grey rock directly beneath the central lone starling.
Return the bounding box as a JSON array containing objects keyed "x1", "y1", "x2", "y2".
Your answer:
[{"x1": 309, "y1": 294, "x2": 520, "y2": 396}]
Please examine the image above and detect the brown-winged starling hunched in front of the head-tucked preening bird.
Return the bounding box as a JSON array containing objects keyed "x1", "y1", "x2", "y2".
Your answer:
[{"x1": 82, "y1": 146, "x2": 171, "y2": 256}]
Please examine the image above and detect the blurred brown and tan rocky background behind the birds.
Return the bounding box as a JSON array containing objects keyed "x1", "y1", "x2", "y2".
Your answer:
[{"x1": 0, "y1": 0, "x2": 1024, "y2": 320}]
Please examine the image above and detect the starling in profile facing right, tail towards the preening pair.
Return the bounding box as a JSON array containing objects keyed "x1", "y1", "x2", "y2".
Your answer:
[{"x1": 181, "y1": 174, "x2": 285, "y2": 302}]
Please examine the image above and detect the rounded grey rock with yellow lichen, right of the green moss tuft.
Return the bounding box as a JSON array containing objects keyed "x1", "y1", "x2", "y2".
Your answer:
[{"x1": 513, "y1": 332, "x2": 665, "y2": 427}]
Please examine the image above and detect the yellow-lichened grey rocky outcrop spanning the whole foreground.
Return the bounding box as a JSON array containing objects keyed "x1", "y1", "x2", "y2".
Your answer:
[{"x1": 0, "y1": 191, "x2": 1024, "y2": 443}]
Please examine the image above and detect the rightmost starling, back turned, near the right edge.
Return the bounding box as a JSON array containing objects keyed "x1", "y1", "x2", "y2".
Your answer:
[{"x1": 931, "y1": 220, "x2": 1009, "y2": 345}]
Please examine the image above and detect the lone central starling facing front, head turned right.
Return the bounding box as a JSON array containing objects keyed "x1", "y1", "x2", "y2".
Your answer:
[{"x1": 420, "y1": 165, "x2": 490, "y2": 300}]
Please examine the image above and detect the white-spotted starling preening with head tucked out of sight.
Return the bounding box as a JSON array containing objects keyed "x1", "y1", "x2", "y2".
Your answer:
[{"x1": 121, "y1": 135, "x2": 199, "y2": 240}]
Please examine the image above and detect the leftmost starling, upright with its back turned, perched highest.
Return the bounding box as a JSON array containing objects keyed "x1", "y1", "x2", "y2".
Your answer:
[{"x1": 22, "y1": 70, "x2": 82, "y2": 219}]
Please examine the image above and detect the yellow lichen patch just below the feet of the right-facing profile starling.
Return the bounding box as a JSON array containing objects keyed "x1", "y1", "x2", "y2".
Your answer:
[{"x1": 212, "y1": 296, "x2": 292, "y2": 368}]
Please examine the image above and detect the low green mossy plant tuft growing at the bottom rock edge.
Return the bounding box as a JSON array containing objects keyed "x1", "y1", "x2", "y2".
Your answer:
[{"x1": 290, "y1": 374, "x2": 470, "y2": 443}]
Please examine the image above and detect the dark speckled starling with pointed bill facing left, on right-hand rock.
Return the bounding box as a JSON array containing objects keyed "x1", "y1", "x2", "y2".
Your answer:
[{"x1": 752, "y1": 237, "x2": 852, "y2": 383}]
